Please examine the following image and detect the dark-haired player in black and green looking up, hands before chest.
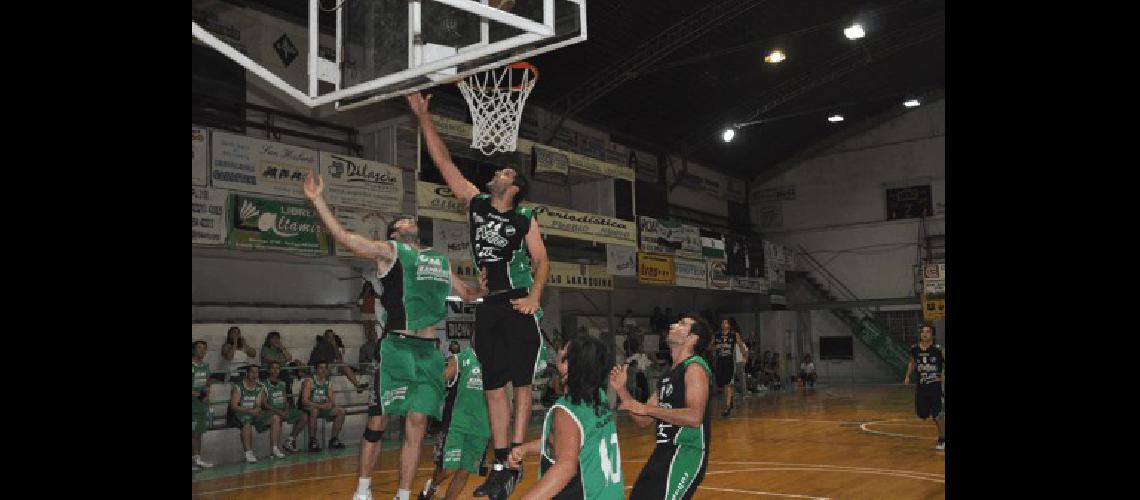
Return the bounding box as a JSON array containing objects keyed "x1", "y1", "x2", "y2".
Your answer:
[{"x1": 610, "y1": 314, "x2": 713, "y2": 500}]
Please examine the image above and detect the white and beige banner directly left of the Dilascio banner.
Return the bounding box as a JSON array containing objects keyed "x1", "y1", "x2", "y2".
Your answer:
[{"x1": 210, "y1": 130, "x2": 319, "y2": 199}]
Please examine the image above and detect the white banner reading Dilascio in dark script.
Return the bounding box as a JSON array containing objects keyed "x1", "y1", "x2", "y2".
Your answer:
[{"x1": 320, "y1": 151, "x2": 404, "y2": 210}]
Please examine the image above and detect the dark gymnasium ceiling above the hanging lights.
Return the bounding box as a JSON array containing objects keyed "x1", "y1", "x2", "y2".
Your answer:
[{"x1": 233, "y1": 0, "x2": 946, "y2": 179}]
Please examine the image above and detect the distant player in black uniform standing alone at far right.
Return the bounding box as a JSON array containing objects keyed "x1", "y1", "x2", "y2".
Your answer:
[{"x1": 903, "y1": 325, "x2": 946, "y2": 450}]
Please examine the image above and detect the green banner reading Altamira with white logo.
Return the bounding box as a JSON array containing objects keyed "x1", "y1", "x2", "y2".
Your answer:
[{"x1": 229, "y1": 195, "x2": 328, "y2": 255}]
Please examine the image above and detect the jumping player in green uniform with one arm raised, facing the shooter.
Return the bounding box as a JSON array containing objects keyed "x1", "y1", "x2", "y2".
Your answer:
[{"x1": 304, "y1": 172, "x2": 480, "y2": 500}]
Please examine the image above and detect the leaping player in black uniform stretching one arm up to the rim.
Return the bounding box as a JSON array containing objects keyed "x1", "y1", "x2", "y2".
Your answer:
[{"x1": 407, "y1": 92, "x2": 549, "y2": 500}]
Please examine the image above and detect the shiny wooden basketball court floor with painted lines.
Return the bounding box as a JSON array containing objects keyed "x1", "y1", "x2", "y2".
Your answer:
[{"x1": 193, "y1": 385, "x2": 946, "y2": 500}]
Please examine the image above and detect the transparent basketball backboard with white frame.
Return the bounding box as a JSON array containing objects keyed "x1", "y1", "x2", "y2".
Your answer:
[{"x1": 193, "y1": 0, "x2": 586, "y2": 110}]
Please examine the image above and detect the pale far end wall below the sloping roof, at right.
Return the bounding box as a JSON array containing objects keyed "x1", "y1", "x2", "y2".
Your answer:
[{"x1": 751, "y1": 100, "x2": 946, "y2": 298}]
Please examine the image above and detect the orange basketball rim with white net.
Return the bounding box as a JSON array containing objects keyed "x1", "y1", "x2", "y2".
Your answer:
[{"x1": 456, "y1": 62, "x2": 538, "y2": 156}]
